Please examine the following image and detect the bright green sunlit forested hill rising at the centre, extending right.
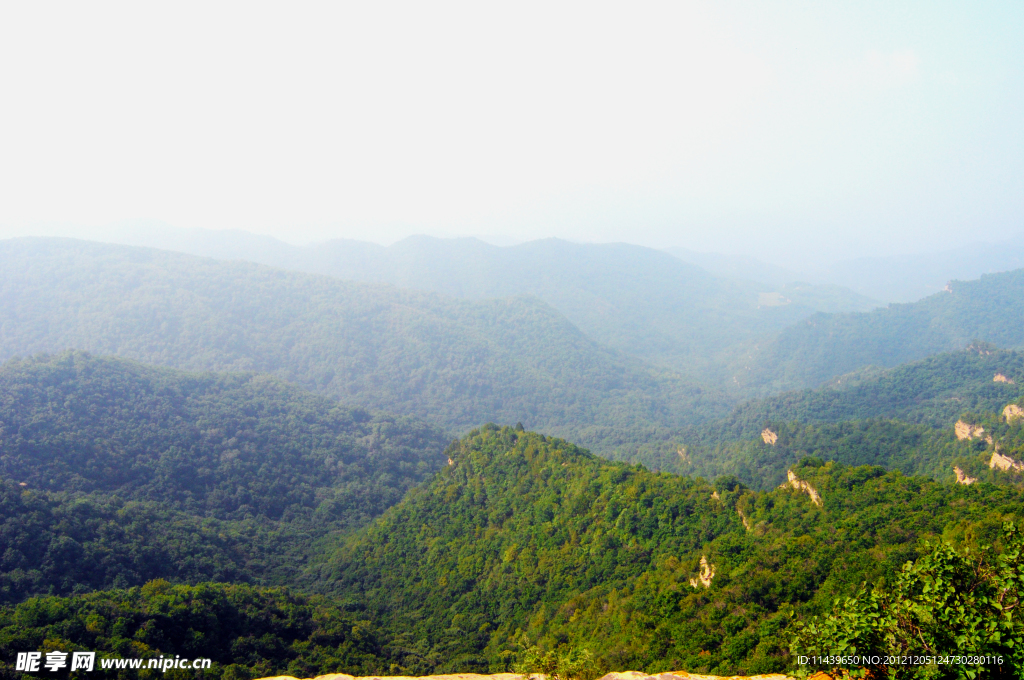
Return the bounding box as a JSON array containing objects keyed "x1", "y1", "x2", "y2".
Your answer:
[{"x1": 323, "y1": 426, "x2": 1024, "y2": 674}]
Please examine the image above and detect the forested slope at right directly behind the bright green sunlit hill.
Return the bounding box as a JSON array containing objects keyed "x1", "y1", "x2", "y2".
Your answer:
[{"x1": 671, "y1": 344, "x2": 1024, "y2": 488}]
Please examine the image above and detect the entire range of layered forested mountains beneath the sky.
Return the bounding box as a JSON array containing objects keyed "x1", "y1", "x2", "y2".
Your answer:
[{"x1": 0, "y1": 232, "x2": 1024, "y2": 680}]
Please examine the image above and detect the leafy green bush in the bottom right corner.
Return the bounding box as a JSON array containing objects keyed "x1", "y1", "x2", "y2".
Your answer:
[{"x1": 791, "y1": 523, "x2": 1024, "y2": 680}]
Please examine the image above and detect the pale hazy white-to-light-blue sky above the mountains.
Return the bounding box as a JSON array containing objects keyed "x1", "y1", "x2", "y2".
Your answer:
[{"x1": 0, "y1": 0, "x2": 1024, "y2": 260}]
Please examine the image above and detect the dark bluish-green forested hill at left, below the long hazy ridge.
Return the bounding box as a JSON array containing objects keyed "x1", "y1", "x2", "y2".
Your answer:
[{"x1": 0, "y1": 352, "x2": 447, "y2": 600}]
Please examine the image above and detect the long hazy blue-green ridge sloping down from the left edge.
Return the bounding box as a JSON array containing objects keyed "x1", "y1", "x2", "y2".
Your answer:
[{"x1": 0, "y1": 239, "x2": 726, "y2": 452}]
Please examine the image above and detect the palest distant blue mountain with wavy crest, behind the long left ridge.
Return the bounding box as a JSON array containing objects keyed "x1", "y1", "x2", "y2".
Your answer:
[{"x1": 97, "y1": 229, "x2": 877, "y2": 383}]
